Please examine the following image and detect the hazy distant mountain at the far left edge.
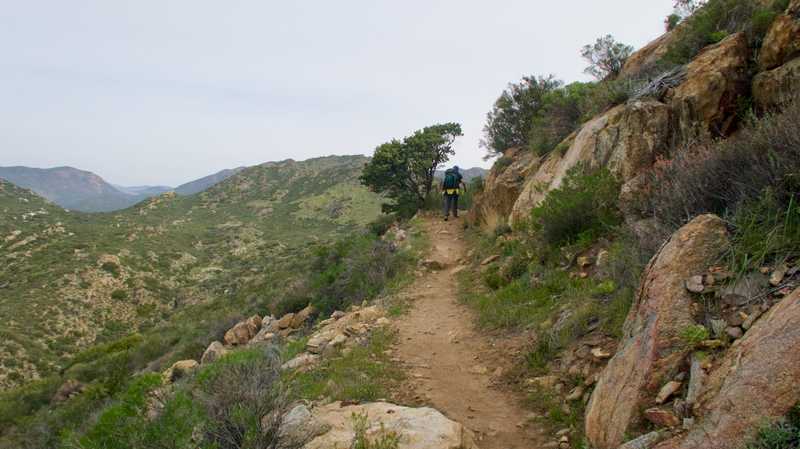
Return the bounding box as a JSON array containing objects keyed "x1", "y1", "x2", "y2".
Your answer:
[{"x1": 0, "y1": 167, "x2": 139, "y2": 212}]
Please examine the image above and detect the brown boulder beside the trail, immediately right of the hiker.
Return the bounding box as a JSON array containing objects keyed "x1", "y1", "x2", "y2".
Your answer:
[{"x1": 467, "y1": 148, "x2": 540, "y2": 230}]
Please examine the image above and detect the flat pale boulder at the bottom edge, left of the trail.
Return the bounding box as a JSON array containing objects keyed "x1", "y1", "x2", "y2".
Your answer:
[{"x1": 303, "y1": 402, "x2": 477, "y2": 449}]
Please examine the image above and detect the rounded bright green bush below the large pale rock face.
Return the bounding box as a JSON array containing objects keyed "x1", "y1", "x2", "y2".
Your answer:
[{"x1": 530, "y1": 165, "x2": 622, "y2": 248}]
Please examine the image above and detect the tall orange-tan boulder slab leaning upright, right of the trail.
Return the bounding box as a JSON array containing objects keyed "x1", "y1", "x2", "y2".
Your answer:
[{"x1": 586, "y1": 215, "x2": 728, "y2": 449}]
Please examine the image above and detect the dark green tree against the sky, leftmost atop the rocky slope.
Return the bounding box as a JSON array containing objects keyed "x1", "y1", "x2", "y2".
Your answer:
[{"x1": 481, "y1": 75, "x2": 562, "y2": 158}]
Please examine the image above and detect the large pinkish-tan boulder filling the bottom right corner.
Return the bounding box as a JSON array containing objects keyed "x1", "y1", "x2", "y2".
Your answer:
[{"x1": 657, "y1": 289, "x2": 800, "y2": 449}]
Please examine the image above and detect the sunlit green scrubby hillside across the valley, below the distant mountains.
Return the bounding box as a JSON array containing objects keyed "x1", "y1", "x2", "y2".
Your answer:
[{"x1": 0, "y1": 157, "x2": 380, "y2": 387}]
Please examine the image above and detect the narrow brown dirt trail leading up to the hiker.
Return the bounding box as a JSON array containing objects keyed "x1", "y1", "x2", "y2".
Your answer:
[{"x1": 396, "y1": 218, "x2": 544, "y2": 449}]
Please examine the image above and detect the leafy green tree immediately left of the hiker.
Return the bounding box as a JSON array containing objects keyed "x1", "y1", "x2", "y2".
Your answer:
[{"x1": 360, "y1": 123, "x2": 462, "y2": 216}]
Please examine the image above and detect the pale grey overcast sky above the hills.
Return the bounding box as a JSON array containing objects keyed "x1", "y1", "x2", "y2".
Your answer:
[{"x1": 0, "y1": 0, "x2": 672, "y2": 186}]
